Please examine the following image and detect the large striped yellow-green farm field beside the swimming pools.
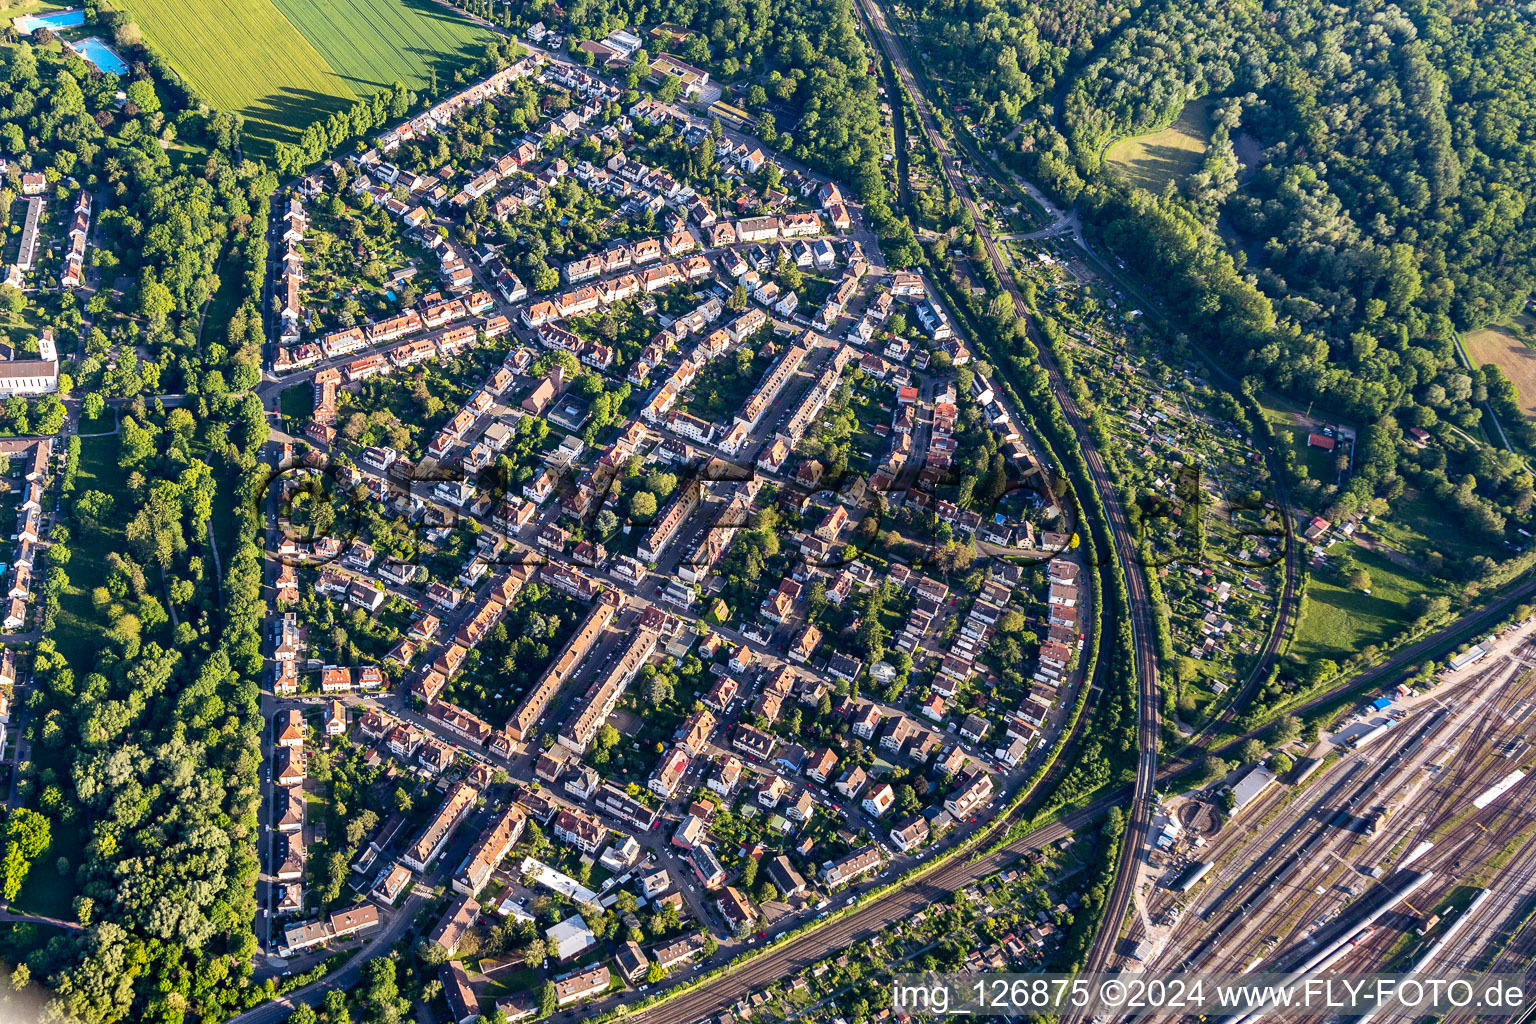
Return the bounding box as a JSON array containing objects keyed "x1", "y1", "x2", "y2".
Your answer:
[{"x1": 121, "y1": 0, "x2": 490, "y2": 157}]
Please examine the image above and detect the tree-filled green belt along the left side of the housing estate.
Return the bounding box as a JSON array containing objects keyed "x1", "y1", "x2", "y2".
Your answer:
[{"x1": 0, "y1": 33, "x2": 288, "y2": 1021}]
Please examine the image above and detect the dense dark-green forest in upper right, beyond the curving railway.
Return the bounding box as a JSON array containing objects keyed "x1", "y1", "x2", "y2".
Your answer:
[{"x1": 912, "y1": 0, "x2": 1536, "y2": 568}]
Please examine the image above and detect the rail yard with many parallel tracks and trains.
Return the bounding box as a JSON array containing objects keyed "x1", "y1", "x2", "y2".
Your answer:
[{"x1": 1115, "y1": 634, "x2": 1536, "y2": 1021}]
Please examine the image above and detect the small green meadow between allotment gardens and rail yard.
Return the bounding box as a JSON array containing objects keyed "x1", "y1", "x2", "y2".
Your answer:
[{"x1": 1290, "y1": 547, "x2": 1430, "y2": 663}]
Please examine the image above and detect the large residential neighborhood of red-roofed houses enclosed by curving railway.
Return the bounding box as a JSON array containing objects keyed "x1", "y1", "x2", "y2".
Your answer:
[{"x1": 239, "y1": 33, "x2": 1087, "y2": 1019}]
